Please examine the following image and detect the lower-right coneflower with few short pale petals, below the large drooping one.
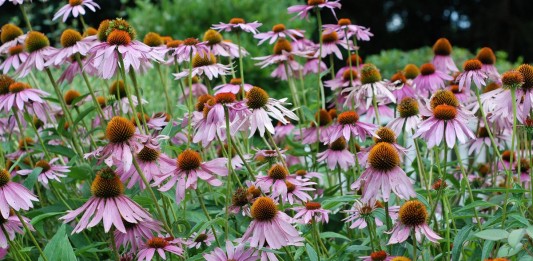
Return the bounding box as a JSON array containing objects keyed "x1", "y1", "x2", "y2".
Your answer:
[{"x1": 388, "y1": 200, "x2": 442, "y2": 245}]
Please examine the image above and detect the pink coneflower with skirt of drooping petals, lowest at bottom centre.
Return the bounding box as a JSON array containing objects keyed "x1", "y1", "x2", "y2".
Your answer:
[{"x1": 239, "y1": 197, "x2": 303, "y2": 249}]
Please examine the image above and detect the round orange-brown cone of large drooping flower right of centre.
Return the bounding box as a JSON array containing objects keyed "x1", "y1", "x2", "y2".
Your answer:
[{"x1": 368, "y1": 142, "x2": 400, "y2": 172}]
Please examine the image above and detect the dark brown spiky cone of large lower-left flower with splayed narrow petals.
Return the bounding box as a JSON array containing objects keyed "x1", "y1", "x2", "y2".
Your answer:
[{"x1": 91, "y1": 168, "x2": 124, "y2": 198}]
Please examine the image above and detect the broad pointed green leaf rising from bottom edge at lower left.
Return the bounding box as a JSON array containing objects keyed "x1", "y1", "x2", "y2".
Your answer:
[{"x1": 39, "y1": 224, "x2": 78, "y2": 261}]
